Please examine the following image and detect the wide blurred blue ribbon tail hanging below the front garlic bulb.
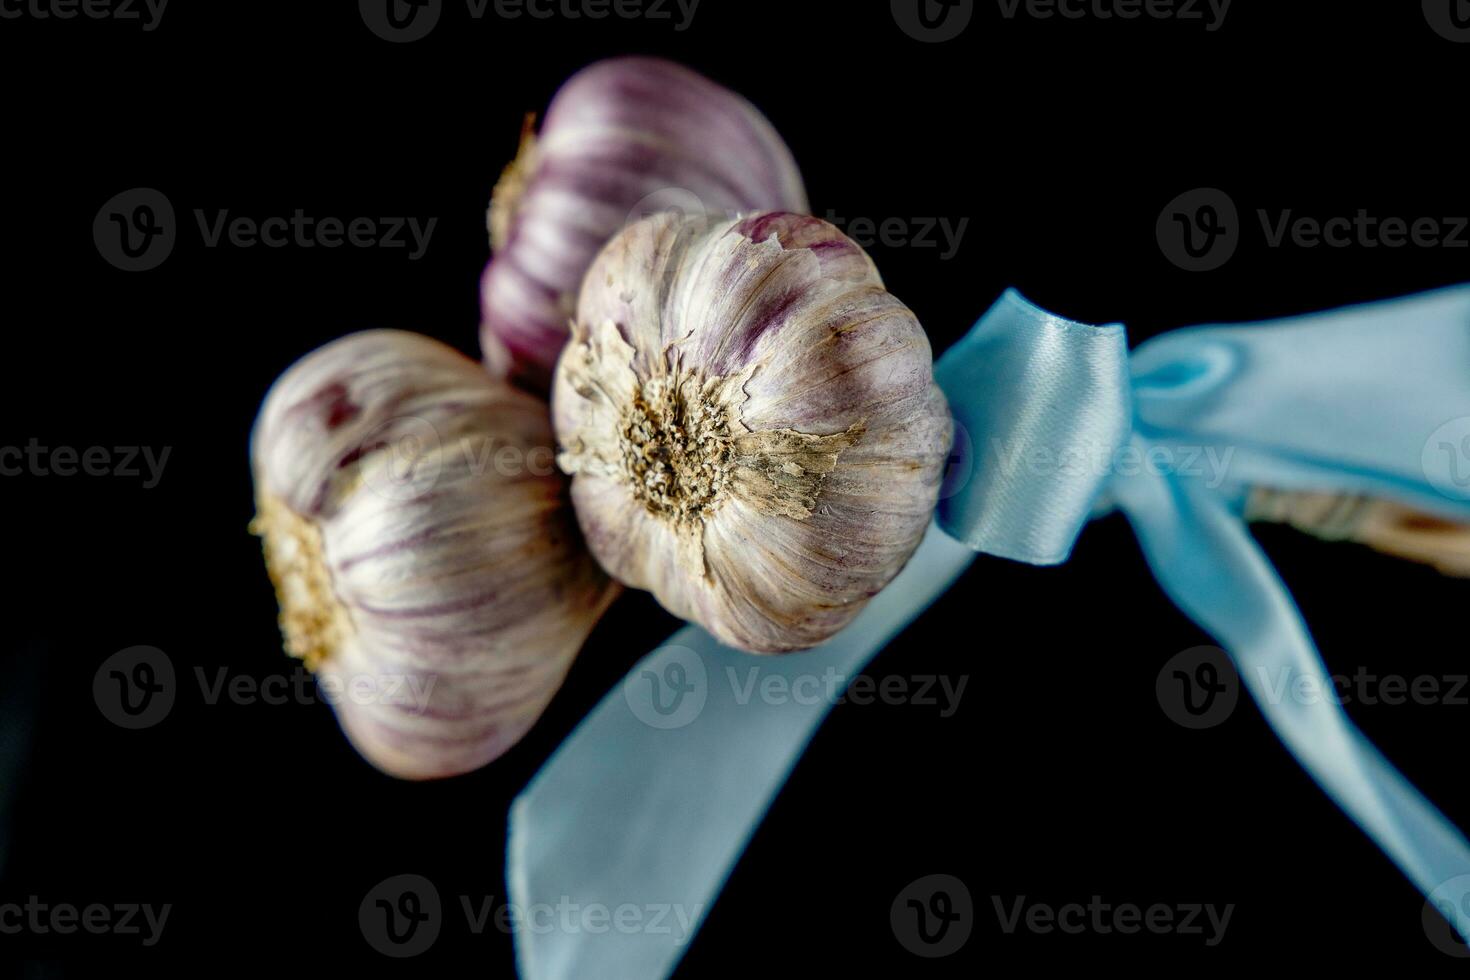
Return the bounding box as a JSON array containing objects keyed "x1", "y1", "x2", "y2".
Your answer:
[{"x1": 506, "y1": 525, "x2": 975, "y2": 980}]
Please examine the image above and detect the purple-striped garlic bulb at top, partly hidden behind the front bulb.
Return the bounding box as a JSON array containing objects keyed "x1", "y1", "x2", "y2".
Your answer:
[{"x1": 481, "y1": 57, "x2": 807, "y2": 391}]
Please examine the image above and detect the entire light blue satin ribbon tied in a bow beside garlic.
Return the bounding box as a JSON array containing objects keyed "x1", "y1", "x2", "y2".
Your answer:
[{"x1": 507, "y1": 288, "x2": 1470, "y2": 980}]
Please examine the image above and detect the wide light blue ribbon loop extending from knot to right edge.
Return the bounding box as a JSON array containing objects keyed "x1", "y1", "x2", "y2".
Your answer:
[{"x1": 1133, "y1": 287, "x2": 1470, "y2": 522}]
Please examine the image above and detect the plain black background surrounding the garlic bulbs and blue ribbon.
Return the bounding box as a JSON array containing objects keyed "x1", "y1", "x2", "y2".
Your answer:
[{"x1": 0, "y1": 0, "x2": 1470, "y2": 977}]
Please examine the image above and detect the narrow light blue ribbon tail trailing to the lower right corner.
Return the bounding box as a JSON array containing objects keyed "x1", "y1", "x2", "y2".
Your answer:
[{"x1": 1114, "y1": 452, "x2": 1470, "y2": 940}]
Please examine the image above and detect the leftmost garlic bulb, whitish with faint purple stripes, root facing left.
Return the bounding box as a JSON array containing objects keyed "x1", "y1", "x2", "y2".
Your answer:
[{"x1": 251, "y1": 331, "x2": 617, "y2": 779}]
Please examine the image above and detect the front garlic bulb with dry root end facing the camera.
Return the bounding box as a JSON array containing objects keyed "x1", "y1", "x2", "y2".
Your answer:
[{"x1": 553, "y1": 213, "x2": 953, "y2": 652}]
